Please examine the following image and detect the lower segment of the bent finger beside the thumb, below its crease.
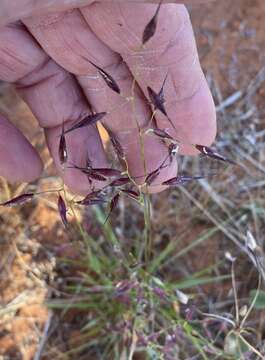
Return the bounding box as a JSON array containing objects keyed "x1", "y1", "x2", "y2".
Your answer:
[{"x1": 17, "y1": 60, "x2": 106, "y2": 194}]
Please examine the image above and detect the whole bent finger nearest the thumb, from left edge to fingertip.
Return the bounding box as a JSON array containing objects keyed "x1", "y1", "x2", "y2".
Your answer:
[{"x1": 0, "y1": 26, "x2": 105, "y2": 193}]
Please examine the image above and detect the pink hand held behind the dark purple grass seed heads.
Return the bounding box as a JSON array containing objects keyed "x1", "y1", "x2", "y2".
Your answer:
[{"x1": 0, "y1": 0, "x2": 216, "y2": 194}]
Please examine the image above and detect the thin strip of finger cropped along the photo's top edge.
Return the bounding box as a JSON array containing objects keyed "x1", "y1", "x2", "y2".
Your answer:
[{"x1": 0, "y1": 0, "x2": 213, "y2": 25}]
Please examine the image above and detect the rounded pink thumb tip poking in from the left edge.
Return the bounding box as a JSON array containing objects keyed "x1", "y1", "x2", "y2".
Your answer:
[{"x1": 0, "y1": 114, "x2": 42, "y2": 182}]
